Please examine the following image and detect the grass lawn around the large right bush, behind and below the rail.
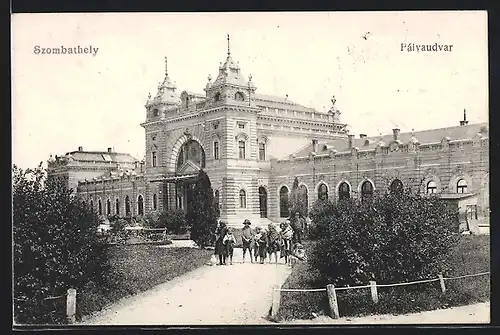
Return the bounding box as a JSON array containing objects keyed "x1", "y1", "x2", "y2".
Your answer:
[{"x1": 277, "y1": 235, "x2": 490, "y2": 321}]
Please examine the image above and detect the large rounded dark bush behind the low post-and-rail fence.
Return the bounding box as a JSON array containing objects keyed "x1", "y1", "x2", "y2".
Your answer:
[{"x1": 310, "y1": 193, "x2": 458, "y2": 285}]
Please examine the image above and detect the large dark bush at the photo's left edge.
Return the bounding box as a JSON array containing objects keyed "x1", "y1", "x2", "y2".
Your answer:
[{"x1": 13, "y1": 164, "x2": 108, "y2": 324}]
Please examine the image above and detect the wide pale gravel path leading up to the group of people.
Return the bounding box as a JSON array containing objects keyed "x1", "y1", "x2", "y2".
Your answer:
[{"x1": 81, "y1": 248, "x2": 291, "y2": 325}]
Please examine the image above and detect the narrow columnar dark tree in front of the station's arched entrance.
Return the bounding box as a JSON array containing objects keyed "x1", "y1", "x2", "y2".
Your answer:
[{"x1": 186, "y1": 170, "x2": 218, "y2": 248}]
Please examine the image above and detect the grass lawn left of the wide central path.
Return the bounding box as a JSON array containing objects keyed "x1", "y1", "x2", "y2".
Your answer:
[{"x1": 77, "y1": 245, "x2": 212, "y2": 319}]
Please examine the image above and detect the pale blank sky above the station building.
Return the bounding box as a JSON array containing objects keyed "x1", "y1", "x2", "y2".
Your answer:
[{"x1": 11, "y1": 11, "x2": 488, "y2": 168}]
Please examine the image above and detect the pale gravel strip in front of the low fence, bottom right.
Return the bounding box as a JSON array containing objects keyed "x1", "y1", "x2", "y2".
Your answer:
[{"x1": 285, "y1": 302, "x2": 490, "y2": 324}]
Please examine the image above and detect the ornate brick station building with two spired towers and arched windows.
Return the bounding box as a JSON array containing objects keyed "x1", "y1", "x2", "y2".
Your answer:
[{"x1": 49, "y1": 39, "x2": 489, "y2": 231}]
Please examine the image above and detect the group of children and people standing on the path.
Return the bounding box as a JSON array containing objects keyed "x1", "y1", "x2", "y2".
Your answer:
[{"x1": 215, "y1": 213, "x2": 307, "y2": 265}]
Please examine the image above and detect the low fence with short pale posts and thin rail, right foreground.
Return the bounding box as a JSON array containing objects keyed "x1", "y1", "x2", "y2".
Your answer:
[{"x1": 271, "y1": 271, "x2": 490, "y2": 319}]
